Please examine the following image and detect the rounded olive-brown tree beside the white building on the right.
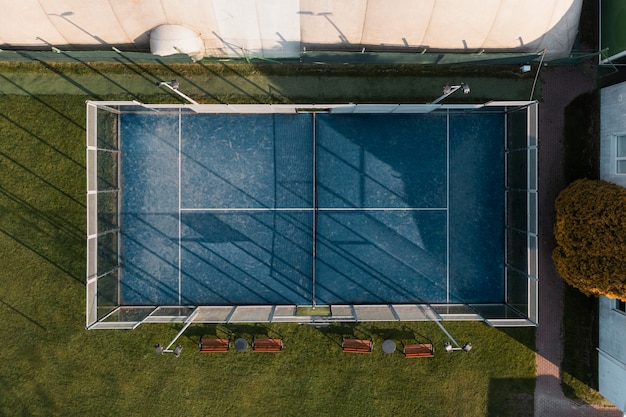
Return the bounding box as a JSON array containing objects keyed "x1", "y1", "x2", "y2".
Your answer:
[{"x1": 552, "y1": 179, "x2": 626, "y2": 301}]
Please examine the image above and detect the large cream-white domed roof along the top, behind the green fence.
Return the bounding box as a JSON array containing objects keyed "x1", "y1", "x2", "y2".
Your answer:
[{"x1": 0, "y1": 0, "x2": 582, "y2": 59}]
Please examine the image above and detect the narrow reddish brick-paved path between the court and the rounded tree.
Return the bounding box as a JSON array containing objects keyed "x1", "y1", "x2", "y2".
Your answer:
[{"x1": 535, "y1": 65, "x2": 622, "y2": 417}]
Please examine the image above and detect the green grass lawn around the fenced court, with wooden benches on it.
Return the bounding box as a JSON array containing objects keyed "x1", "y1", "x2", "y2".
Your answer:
[{"x1": 0, "y1": 65, "x2": 535, "y2": 416}]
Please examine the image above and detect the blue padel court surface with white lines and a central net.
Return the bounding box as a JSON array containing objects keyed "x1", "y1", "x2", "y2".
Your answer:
[{"x1": 120, "y1": 112, "x2": 505, "y2": 305}]
